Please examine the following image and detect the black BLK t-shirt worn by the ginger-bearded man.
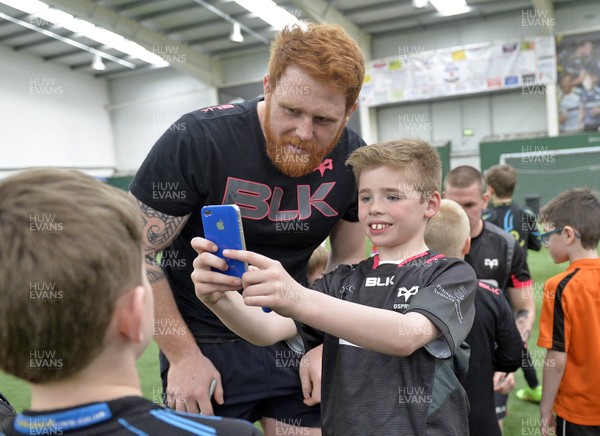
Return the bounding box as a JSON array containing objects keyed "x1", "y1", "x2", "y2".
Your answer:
[{"x1": 130, "y1": 99, "x2": 364, "y2": 343}]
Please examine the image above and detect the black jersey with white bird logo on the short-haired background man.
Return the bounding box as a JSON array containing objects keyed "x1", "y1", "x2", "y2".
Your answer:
[{"x1": 465, "y1": 221, "x2": 532, "y2": 291}]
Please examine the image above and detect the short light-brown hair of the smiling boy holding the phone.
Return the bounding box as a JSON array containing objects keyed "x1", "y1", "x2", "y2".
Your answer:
[{"x1": 346, "y1": 138, "x2": 442, "y2": 202}]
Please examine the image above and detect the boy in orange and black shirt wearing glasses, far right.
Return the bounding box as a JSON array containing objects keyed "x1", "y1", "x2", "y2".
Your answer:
[{"x1": 538, "y1": 189, "x2": 600, "y2": 436}]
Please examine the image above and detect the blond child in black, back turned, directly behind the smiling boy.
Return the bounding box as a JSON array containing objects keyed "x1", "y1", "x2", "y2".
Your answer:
[{"x1": 425, "y1": 199, "x2": 523, "y2": 436}]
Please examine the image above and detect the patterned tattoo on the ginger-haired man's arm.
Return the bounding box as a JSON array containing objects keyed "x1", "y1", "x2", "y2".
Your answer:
[{"x1": 136, "y1": 199, "x2": 189, "y2": 285}]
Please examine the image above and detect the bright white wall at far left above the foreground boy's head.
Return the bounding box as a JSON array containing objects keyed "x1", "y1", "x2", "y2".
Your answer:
[{"x1": 0, "y1": 46, "x2": 116, "y2": 178}]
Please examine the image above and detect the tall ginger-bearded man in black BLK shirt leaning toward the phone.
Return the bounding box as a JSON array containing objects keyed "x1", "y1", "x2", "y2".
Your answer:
[{"x1": 130, "y1": 24, "x2": 364, "y2": 434}]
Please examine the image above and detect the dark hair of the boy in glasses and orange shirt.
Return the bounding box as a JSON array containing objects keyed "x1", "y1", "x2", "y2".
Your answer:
[{"x1": 539, "y1": 188, "x2": 600, "y2": 250}]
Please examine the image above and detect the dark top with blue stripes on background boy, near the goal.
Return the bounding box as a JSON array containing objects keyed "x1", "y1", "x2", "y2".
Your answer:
[{"x1": 483, "y1": 203, "x2": 542, "y2": 250}]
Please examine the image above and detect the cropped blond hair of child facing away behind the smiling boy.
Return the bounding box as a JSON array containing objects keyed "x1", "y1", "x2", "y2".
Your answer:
[{"x1": 425, "y1": 199, "x2": 471, "y2": 258}]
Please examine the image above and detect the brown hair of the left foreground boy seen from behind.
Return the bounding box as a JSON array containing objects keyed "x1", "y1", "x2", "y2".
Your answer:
[{"x1": 0, "y1": 169, "x2": 142, "y2": 383}]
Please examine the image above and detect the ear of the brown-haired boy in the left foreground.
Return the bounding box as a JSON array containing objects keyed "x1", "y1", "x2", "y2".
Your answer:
[{"x1": 115, "y1": 286, "x2": 147, "y2": 342}]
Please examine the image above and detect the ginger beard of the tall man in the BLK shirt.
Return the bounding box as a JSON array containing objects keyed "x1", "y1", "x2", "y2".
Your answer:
[{"x1": 265, "y1": 100, "x2": 345, "y2": 177}]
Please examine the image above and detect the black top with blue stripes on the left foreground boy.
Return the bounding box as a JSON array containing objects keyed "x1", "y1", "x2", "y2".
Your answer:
[{"x1": 5, "y1": 397, "x2": 262, "y2": 436}]
